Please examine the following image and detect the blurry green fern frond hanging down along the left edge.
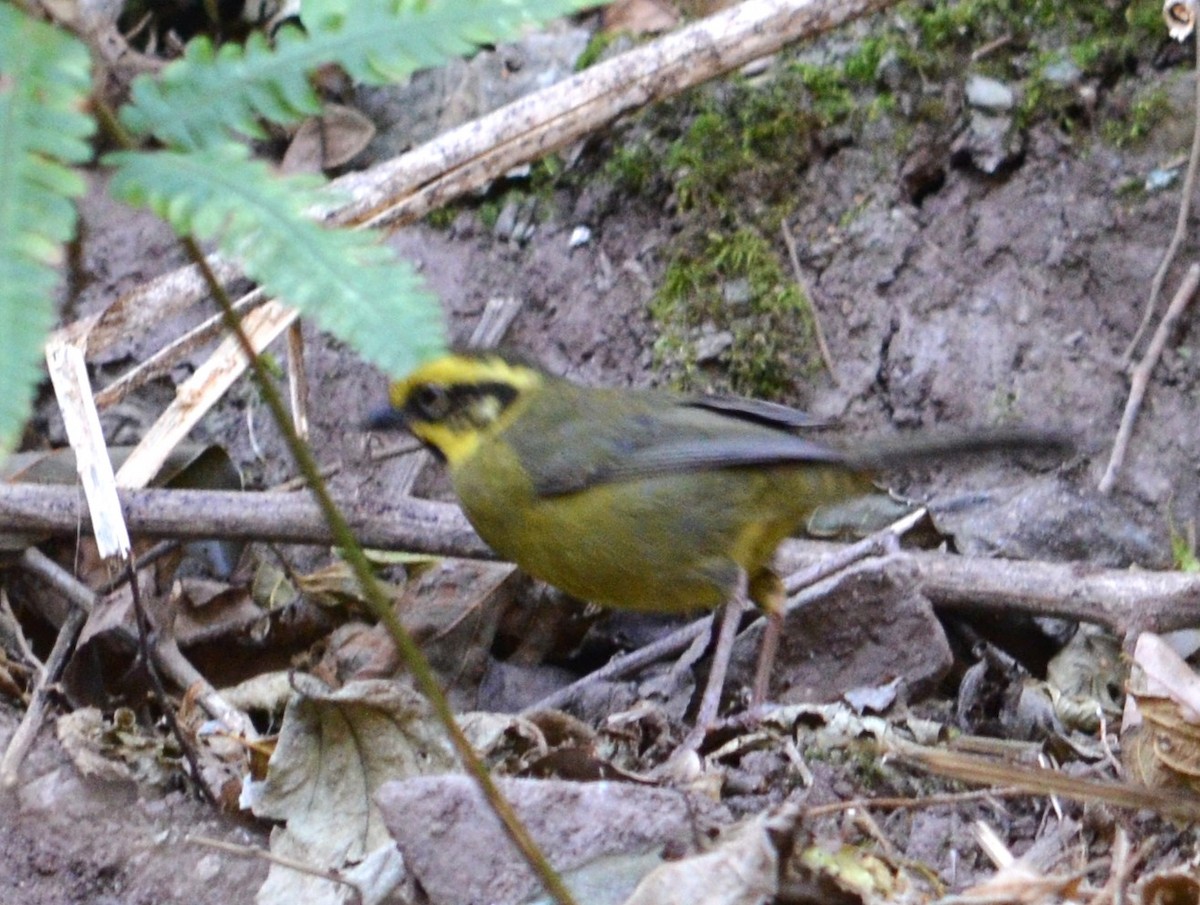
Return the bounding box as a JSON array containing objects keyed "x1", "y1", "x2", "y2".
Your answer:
[{"x1": 0, "y1": 5, "x2": 95, "y2": 454}]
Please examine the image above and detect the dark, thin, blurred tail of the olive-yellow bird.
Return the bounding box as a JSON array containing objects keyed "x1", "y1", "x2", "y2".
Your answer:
[{"x1": 845, "y1": 427, "x2": 1075, "y2": 472}]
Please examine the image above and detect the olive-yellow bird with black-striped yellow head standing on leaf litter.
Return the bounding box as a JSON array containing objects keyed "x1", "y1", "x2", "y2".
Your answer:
[{"x1": 367, "y1": 350, "x2": 1066, "y2": 729}]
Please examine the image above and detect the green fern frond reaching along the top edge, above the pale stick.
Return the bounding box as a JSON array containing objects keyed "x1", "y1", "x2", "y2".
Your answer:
[{"x1": 121, "y1": 0, "x2": 595, "y2": 149}]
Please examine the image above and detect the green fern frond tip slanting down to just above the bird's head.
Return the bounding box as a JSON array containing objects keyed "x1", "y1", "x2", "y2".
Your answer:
[{"x1": 106, "y1": 144, "x2": 445, "y2": 373}]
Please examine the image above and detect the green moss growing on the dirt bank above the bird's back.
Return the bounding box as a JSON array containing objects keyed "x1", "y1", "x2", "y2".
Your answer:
[{"x1": 590, "y1": 0, "x2": 1166, "y2": 391}]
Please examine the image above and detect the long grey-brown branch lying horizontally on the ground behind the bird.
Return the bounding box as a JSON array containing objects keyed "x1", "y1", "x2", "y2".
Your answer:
[{"x1": 0, "y1": 484, "x2": 1200, "y2": 635}]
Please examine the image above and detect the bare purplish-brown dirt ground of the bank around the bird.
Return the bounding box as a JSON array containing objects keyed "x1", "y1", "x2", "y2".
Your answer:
[{"x1": 0, "y1": 1, "x2": 1200, "y2": 905}]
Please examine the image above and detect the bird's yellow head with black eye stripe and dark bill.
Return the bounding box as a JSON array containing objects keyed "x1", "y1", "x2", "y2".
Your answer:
[{"x1": 366, "y1": 352, "x2": 546, "y2": 466}]
